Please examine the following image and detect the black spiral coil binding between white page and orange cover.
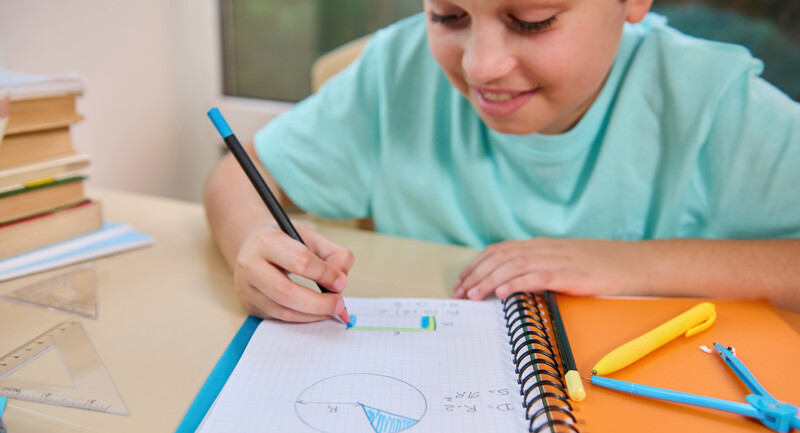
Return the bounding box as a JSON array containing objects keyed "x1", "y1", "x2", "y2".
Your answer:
[{"x1": 503, "y1": 293, "x2": 579, "y2": 433}]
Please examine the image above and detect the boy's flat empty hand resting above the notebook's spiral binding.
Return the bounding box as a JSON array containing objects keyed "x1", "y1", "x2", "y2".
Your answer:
[{"x1": 454, "y1": 238, "x2": 648, "y2": 299}]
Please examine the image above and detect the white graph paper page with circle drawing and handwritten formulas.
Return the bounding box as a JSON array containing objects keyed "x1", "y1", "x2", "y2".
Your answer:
[{"x1": 198, "y1": 298, "x2": 527, "y2": 433}]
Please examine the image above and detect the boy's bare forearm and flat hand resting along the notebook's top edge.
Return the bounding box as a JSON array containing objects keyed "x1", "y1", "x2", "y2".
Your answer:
[{"x1": 454, "y1": 238, "x2": 800, "y2": 312}]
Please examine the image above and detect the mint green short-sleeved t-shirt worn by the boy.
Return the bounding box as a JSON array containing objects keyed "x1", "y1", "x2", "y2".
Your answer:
[{"x1": 255, "y1": 14, "x2": 800, "y2": 248}]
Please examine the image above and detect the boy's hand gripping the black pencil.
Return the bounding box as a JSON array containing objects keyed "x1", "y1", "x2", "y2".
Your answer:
[{"x1": 233, "y1": 223, "x2": 354, "y2": 322}]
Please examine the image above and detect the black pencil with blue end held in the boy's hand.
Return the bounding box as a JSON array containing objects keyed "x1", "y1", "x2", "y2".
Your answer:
[{"x1": 208, "y1": 107, "x2": 350, "y2": 324}]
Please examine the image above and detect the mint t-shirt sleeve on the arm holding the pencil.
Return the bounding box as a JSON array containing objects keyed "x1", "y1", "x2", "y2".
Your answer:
[{"x1": 255, "y1": 37, "x2": 381, "y2": 218}]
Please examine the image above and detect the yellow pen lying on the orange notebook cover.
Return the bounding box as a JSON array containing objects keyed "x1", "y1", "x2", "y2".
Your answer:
[{"x1": 592, "y1": 302, "x2": 717, "y2": 376}]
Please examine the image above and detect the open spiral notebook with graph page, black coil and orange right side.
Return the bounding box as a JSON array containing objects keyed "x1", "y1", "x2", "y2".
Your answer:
[{"x1": 184, "y1": 294, "x2": 800, "y2": 433}]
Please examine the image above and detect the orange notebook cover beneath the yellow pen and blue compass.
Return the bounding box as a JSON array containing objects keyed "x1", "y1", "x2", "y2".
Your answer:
[{"x1": 558, "y1": 296, "x2": 800, "y2": 433}]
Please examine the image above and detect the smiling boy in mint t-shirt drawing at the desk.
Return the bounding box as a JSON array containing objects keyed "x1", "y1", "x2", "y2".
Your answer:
[{"x1": 206, "y1": 0, "x2": 800, "y2": 321}]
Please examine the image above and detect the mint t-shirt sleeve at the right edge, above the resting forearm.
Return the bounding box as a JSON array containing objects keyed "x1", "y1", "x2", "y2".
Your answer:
[{"x1": 696, "y1": 71, "x2": 800, "y2": 239}]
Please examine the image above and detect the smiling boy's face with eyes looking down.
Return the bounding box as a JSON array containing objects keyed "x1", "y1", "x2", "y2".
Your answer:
[{"x1": 425, "y1": 0, "x2": 651, "y2": 134}]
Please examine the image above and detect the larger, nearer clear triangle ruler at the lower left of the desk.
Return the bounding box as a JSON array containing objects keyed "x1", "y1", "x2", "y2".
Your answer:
[{"x1": 0, "y1": 321, "x2": 129, "y2": 415}]
